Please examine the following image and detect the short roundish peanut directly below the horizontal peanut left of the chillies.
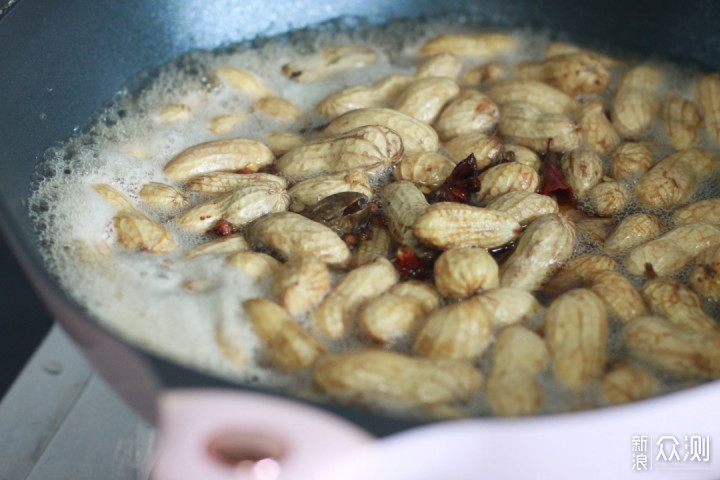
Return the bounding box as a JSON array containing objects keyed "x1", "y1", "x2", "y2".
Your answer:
[{"x1": 270, "y1": 256, "x2": 330, "y2": 316}]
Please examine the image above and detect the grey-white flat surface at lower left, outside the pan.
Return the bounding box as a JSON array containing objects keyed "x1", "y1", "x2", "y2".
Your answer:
[{"x1": 0, "y1": 325, "x2": 154, "y2": 480}]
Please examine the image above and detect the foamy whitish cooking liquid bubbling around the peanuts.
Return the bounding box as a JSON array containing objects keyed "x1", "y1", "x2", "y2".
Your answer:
[{"x1": 30, "y1": 16, "x2": 720, "y2": 415}]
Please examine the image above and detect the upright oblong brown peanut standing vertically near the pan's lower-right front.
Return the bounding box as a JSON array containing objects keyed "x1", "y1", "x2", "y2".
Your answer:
[{"x1": 545, "y1": 289, "x2": 608, "y2": 389}]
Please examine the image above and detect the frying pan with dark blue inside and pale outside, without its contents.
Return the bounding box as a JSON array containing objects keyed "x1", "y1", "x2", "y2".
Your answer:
[{"x1": 0, "y1": 0, "x2": 720, "y2": 478}]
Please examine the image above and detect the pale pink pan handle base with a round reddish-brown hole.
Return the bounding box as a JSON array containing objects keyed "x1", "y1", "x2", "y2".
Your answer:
[{"x1": 150, "y1": 390, "x2": 374, "y2": 480}]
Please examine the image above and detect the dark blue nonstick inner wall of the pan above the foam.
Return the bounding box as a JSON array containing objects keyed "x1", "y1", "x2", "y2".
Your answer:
[{"x1": 0, "y1": 0, "x2": 720, "y2": 435}]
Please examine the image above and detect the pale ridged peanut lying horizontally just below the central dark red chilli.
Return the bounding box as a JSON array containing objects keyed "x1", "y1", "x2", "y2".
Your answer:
[{"x1": 413, "y1": 202, "x2": 520, "y2": 250}]
